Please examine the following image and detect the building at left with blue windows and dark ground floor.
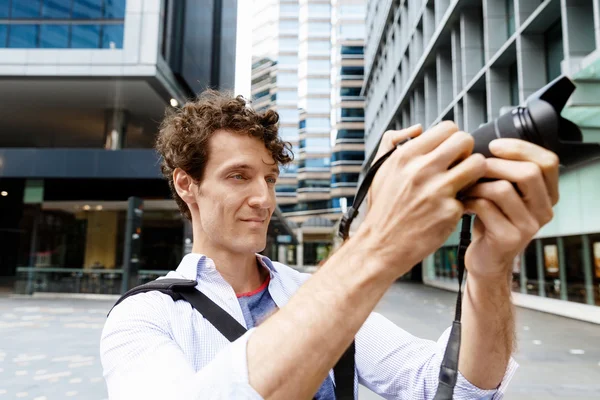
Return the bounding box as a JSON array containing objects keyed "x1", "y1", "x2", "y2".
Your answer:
[{"x1": 0, "y1": 0, "x2": 296, "y2": 293}]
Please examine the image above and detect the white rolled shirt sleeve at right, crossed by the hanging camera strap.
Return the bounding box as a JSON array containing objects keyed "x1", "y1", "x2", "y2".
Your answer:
[{"x1": 355, "y1": 313, "x2": 517, "y2": 400}]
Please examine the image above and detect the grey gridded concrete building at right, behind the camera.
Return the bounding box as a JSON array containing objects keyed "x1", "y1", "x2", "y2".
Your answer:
[{"x1": 363, "y1": 0, "x2": 600, "y2": 322}]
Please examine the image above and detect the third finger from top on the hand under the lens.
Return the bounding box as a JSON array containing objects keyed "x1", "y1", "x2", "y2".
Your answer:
[{"x1": 465, "y1": 180, "x2": 540, "y2": 236}]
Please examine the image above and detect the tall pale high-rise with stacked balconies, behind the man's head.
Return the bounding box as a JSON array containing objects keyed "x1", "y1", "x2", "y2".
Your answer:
[{"x1": 252, "y1": 0, "x2": 365, "y2": 265}]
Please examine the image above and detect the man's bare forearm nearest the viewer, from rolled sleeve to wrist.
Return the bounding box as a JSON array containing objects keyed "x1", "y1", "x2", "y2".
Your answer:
[{"x1": 247, "y1": 227, "x2": 396, "y2": 399}]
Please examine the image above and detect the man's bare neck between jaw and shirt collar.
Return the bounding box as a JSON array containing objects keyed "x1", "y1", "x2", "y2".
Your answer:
[{"x1": 192, "y1": 244, "x2": 268, "y2": 293}]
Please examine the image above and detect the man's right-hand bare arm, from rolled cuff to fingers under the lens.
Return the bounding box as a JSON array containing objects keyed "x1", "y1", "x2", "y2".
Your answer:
[{"x1": 459, "y1": 139, "x2": 559, "y2": 389}]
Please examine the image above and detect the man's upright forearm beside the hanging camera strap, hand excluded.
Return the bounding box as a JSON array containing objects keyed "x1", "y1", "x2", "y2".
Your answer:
[{"x1": 459, "y1": 270, "x2": 515, "y2": 389}]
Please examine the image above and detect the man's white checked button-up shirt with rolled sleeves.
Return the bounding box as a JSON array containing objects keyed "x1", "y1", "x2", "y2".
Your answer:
[{"x1": 100, "y1": 254, "x2": 517, "y2": 400}]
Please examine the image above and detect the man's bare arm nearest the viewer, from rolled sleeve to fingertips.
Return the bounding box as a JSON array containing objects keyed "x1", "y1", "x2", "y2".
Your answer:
[{"x1": 248, "y1": 122, "x2": 485, "y2": 399}]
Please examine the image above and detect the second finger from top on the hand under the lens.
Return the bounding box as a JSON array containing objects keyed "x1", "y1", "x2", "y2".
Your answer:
[{"x1": 485, "y1": 158, "x2": 553, "y2": 226}]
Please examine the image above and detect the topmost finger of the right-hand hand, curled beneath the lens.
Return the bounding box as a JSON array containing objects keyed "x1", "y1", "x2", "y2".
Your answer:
[{"x1": 490, "y1": 139, "x2": 559, "y2": 205}]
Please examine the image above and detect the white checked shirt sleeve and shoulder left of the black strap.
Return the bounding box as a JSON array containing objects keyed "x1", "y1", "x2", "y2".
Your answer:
[{"x1": 100, "y1": 293, "x2": 262, "y2": 400}]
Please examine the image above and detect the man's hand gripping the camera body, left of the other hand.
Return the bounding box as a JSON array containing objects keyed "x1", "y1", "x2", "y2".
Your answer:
[{"x1": 357, "y1": 121, "x2": 486, "y2": 278}]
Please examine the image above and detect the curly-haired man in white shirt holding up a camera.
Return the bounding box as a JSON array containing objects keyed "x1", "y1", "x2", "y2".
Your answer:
[{"x1": 101, "y1": 91, "x2": 558, "y2": 399}]
